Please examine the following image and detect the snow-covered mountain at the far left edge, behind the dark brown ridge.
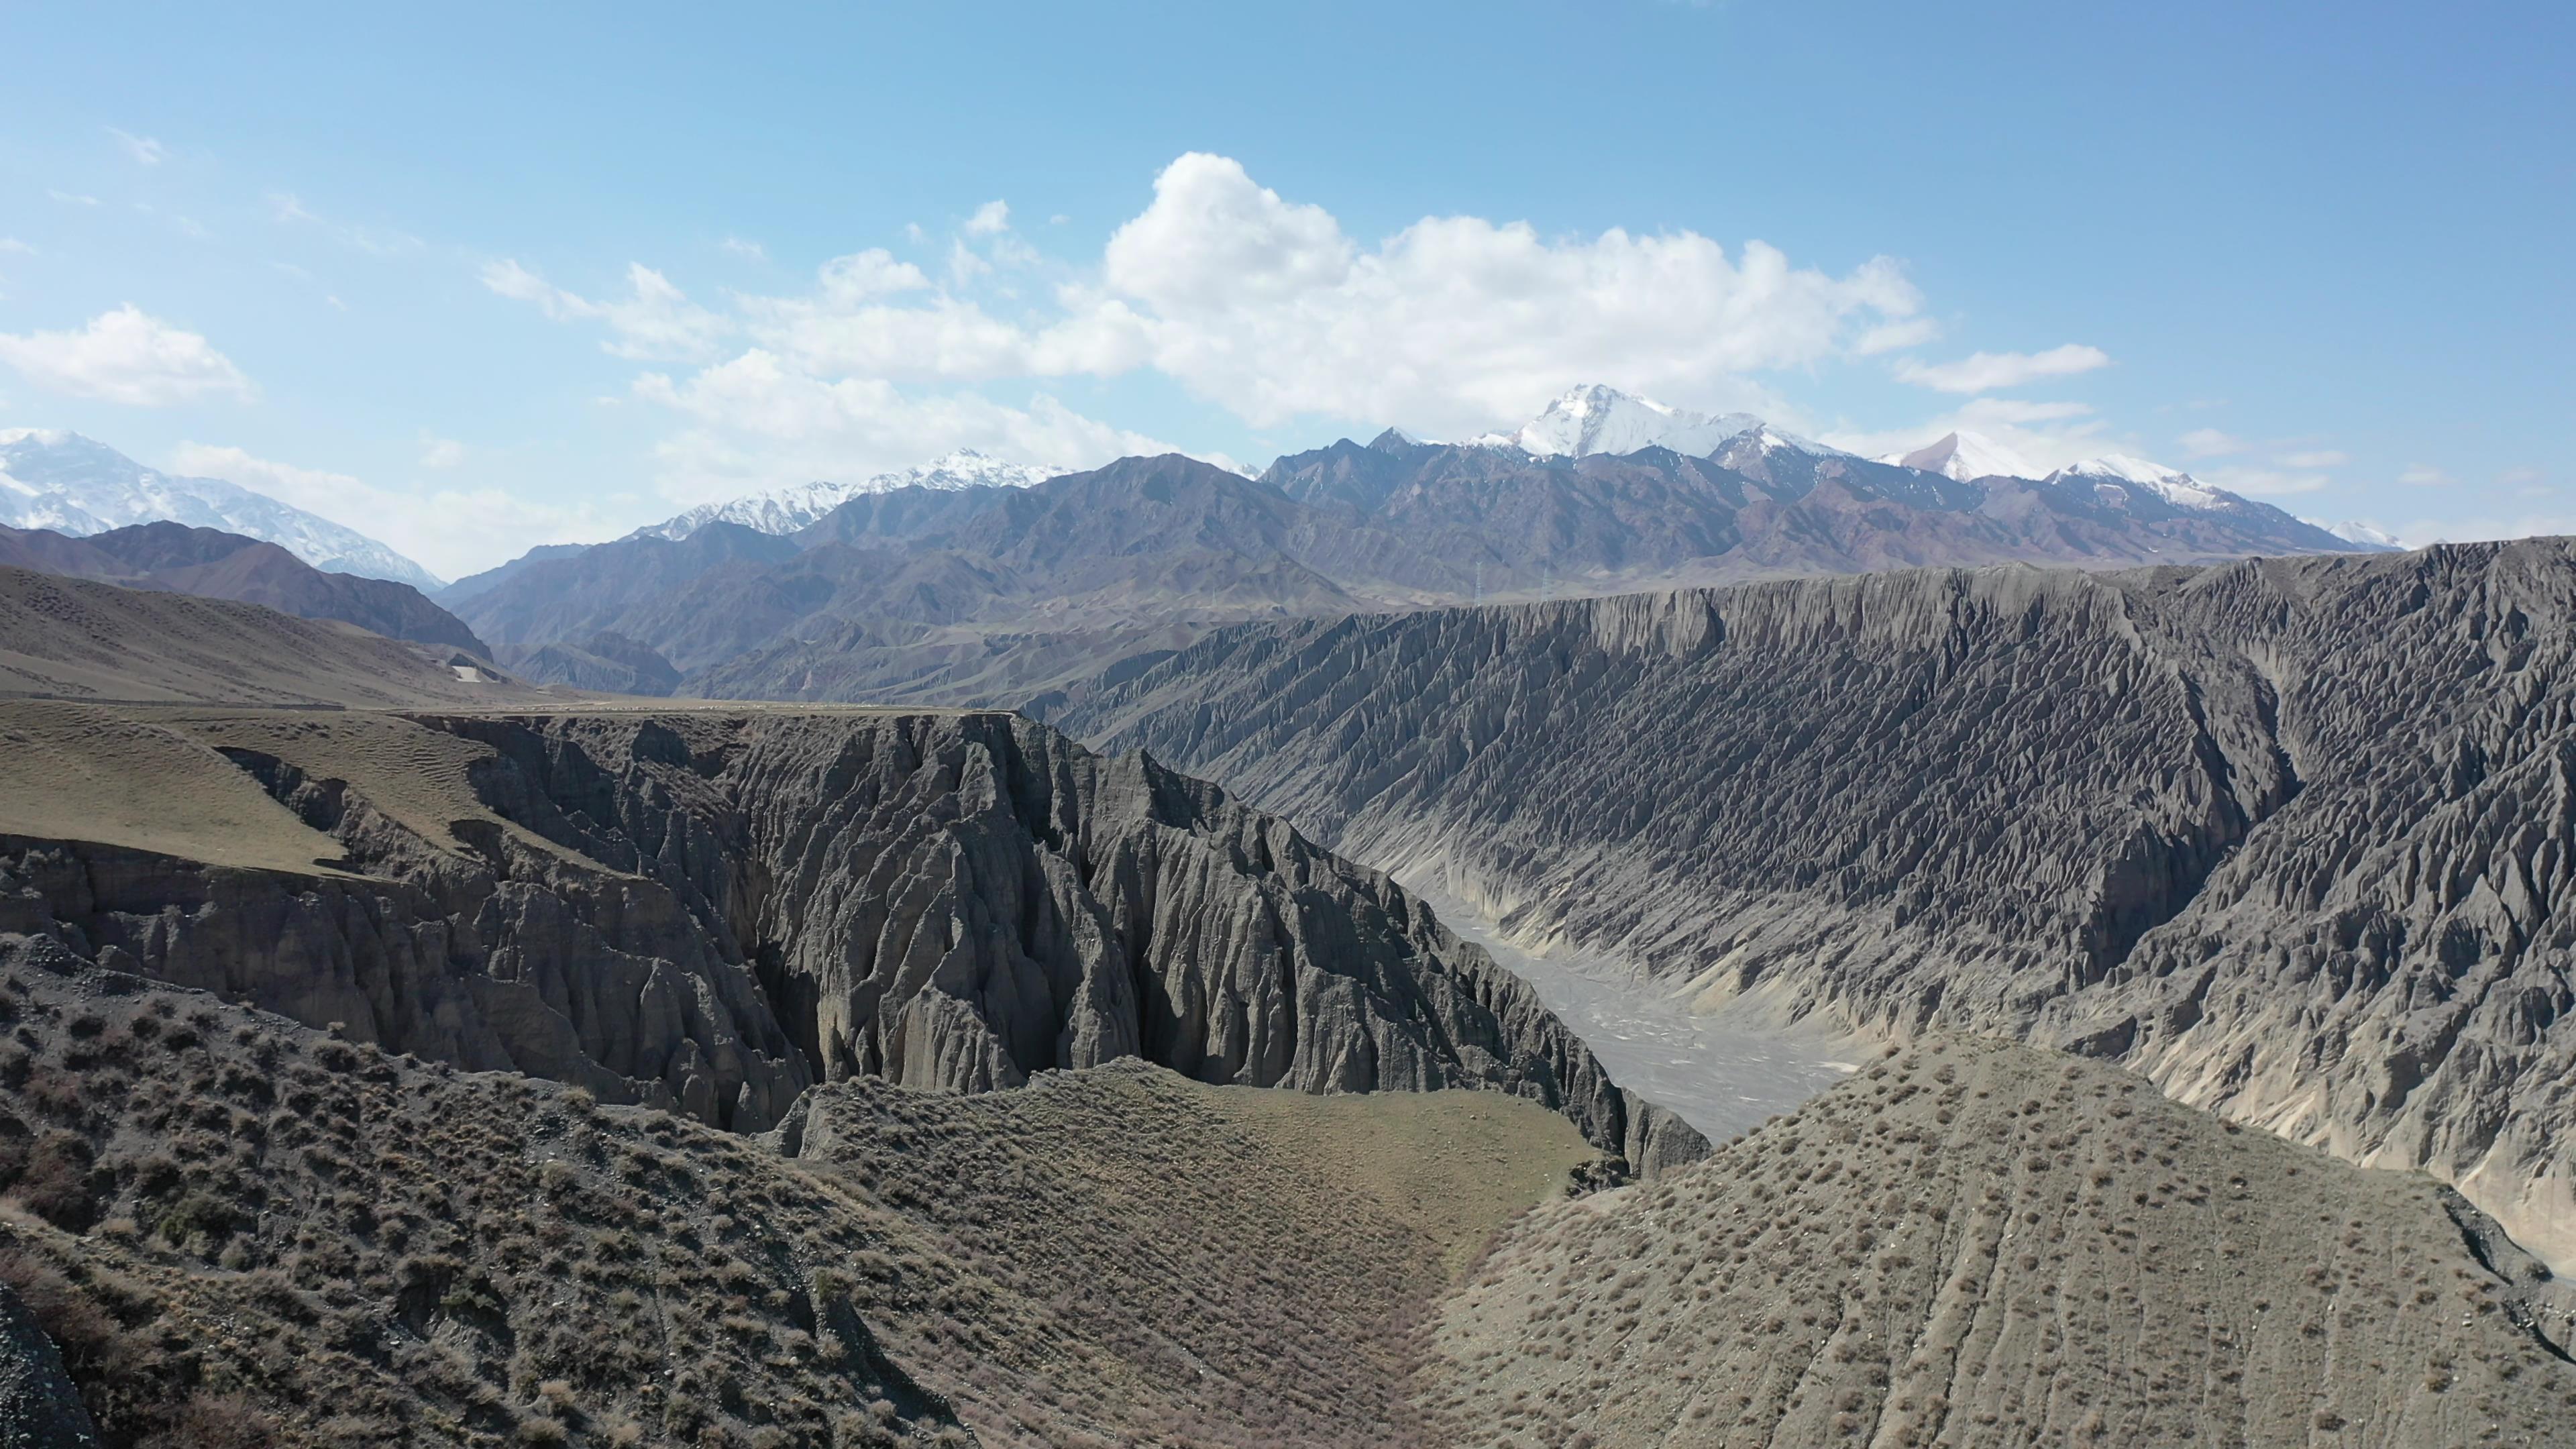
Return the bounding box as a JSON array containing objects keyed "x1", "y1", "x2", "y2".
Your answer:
[{"x1": 0, "y1": 428, "x2": 443, "y2": 593}]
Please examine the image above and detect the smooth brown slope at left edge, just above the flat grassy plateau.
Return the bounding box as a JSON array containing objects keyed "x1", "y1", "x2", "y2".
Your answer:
[{"x1": 0, "y1": 568, "x2": 549, "y2": 706}]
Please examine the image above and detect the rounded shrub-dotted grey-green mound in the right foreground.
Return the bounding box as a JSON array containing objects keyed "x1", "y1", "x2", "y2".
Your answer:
[{"x1": 1425, "y1": 1042, "x2": 2576, "y2": 1449}]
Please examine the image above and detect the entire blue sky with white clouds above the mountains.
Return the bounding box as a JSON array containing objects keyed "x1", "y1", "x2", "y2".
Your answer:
[{"x1": 0, "y1": 0, "x2": 2576, "y2": 575}]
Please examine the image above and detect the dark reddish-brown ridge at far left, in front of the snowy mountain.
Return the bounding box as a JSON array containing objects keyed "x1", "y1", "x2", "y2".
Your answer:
[{"x1": 0, "y1": 523, "x2": 492, "y2": 657}]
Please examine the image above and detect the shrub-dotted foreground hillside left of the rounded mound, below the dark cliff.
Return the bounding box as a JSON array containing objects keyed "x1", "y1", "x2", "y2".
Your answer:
[{"x1": 0, "y1": 954, "x2": 1589, "y2": 1449}]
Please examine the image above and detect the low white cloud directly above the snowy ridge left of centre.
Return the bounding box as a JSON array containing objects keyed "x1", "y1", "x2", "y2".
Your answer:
[{"x1": 634, "y1": 348, "x2": 1175, "y2": 505}]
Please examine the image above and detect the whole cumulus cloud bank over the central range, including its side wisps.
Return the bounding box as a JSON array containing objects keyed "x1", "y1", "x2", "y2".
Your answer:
[{"x1": 502, "y1": 152, "x2": 2110, "y2": 495}]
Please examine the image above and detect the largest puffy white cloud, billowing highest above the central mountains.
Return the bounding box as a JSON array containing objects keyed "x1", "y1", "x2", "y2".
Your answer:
[{"x1": 695, "y1": 155, "x2": 1924, "y2": 436}]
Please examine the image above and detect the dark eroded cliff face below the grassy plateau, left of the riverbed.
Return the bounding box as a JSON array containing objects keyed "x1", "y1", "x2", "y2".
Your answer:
[{"x1": 0, "y1": 712, "x2": 1705, "y2": 1171}]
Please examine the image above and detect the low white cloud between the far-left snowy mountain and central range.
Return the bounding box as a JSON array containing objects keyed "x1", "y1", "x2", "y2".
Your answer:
[{"x1": 165, "y1": 443, "x2": 636, "y2": 578}]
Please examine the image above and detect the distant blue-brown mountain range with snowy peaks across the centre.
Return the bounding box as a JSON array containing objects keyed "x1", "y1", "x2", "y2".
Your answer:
[{"x1": 396, "y1": 389, "x2": 2367, "y2": 712}]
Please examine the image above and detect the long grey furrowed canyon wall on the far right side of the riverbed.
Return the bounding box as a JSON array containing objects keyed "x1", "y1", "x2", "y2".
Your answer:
[{"x1": 1064, "y1": 539, "x2": 2576, "y2": 1263}]
